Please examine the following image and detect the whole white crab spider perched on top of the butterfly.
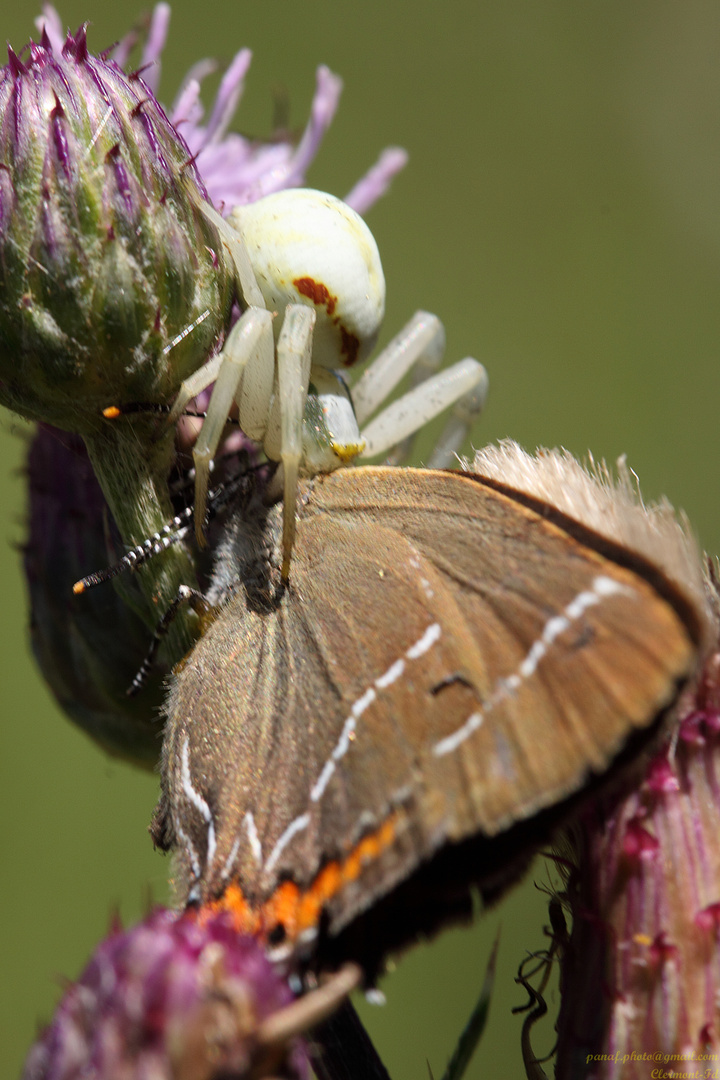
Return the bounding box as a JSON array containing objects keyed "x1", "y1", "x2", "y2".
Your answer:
[{"x1": 175, "y1": 189, "x2": 487, "y2": 580}]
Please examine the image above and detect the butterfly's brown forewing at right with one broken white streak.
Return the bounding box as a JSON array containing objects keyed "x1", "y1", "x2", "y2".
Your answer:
[{"x1": 306, "y1": 470, "x2": 697, "y2": 839}]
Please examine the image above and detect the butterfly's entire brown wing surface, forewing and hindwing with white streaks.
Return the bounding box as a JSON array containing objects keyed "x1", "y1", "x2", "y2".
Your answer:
[{"x1": 156, "y1": 469, "x2": 696, "y2": 954}]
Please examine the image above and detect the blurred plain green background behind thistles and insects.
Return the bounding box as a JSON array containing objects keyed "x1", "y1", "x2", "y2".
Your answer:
[{"x1": 0, "y1": 0, "x2": 720, "y2": 1080}]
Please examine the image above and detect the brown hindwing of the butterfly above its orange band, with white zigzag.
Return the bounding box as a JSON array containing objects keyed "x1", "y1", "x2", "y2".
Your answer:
[{"x1": 163, "y1": 503, "x2": 487, "y2": 904}]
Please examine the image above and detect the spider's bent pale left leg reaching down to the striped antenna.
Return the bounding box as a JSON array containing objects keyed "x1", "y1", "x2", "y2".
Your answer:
[{"x1": 192, "y1": 308, "x2": 275, "y2": 546}]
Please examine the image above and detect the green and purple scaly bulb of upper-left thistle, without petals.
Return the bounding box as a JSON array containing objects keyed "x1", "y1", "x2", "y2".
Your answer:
[{"x1": 0, "y1": 27, "x2": 232, "y2": 434}]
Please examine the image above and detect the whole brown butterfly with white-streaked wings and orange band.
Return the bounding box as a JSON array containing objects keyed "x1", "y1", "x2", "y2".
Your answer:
[{"x1": 152, "y1": 444, "x2": 710, "y2": 972}]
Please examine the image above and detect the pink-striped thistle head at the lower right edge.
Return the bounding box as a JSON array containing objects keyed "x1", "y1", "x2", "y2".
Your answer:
[{"x1": 556, "y1": 582, "x2": 720, "y2": 1080}]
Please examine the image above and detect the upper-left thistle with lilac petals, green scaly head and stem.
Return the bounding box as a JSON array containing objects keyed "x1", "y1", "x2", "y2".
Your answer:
[{"x1": 0, "y1": 4, "x2": 405, "y2": 654}]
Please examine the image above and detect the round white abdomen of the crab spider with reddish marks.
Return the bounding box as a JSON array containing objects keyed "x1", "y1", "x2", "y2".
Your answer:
[{"x1": 229, "y1": 188, "x2": 385, "y2": 367}]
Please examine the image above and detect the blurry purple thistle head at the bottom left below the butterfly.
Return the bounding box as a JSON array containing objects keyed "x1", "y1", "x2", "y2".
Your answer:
[{"x1": 23, "y1": 908, "x2": 310, "y2": 1080}]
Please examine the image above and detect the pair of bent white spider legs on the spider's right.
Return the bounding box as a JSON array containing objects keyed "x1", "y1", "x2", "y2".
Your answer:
[{"x1": 352, "y1": 311, "x2": 488, "y2": 469}]
